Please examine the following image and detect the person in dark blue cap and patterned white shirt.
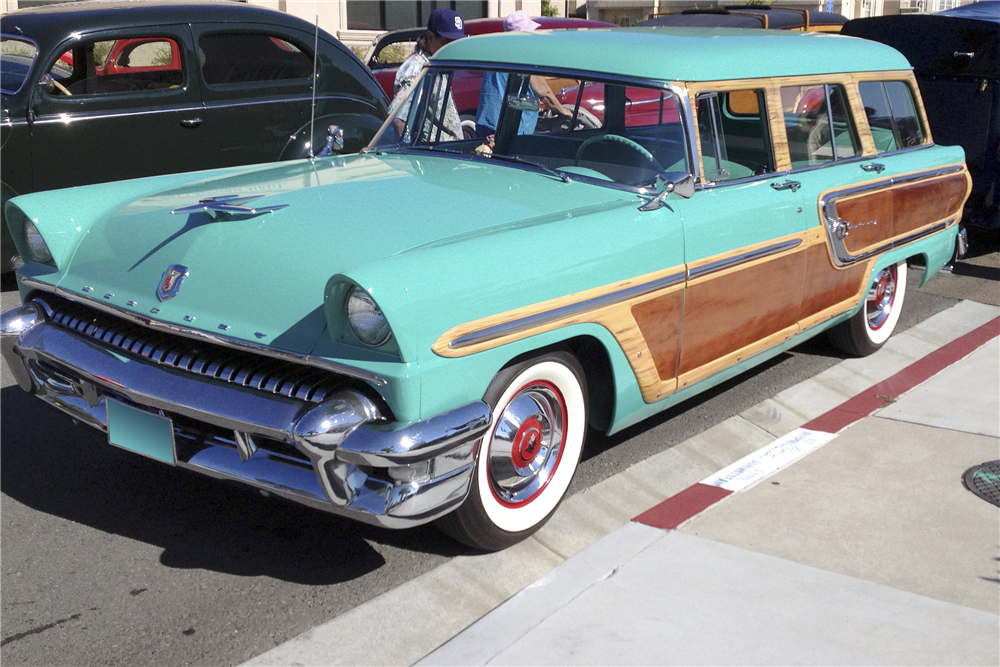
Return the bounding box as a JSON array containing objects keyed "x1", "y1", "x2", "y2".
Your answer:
[{"x1": 389, "y1": 9, "x2": 465, "y2": 141}]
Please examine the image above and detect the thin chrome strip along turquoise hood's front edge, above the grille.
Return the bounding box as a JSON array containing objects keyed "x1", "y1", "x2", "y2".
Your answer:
[{"x1": 21, "y1": 276, "x2": 388, "y2": 387}]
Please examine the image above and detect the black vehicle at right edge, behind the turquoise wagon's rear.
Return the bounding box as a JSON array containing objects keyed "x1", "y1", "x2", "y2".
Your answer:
[{"x1": 843, "y1": 2, "x2": 1000, "y2": 231}]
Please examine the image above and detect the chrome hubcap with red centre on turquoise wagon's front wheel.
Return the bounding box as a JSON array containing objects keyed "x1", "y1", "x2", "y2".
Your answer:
[{"x1": 487, "y1": 382, "x2": 566, "y2": 506}]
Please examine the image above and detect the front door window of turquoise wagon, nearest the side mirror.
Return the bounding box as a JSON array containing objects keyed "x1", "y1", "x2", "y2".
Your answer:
[{"x1": 695, "y1": 89, "x2": 774, "y2": 181}]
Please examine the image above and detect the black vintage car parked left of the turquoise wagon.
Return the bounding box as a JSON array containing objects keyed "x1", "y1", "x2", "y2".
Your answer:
[{"x1": 0, "y1": 0, "x2": 387, "y2": 272}]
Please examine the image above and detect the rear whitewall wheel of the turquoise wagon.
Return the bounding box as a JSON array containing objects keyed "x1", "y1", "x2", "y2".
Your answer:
[{"x1": 827, "y1": 261, "x2": 906, "y2": 357}]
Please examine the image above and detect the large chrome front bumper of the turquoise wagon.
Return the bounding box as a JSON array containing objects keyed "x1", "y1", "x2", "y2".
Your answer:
[{"x1": 0, "y1": 300, "x2": 491, "y2": 528}]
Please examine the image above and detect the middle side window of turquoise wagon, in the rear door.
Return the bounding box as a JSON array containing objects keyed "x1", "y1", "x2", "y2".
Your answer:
[{"x1": 781, "y1": 84, "x2": 861, "y2": 167}]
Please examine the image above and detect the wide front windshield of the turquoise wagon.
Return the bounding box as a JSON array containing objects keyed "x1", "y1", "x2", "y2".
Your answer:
[{"x1": 369, "y1": 68, "x2": 690, "y2": 188}]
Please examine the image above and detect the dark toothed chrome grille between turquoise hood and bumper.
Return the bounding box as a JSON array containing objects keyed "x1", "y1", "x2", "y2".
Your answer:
[{"x1": 45, "y1": 295, "x2": 349, "y2": 403}]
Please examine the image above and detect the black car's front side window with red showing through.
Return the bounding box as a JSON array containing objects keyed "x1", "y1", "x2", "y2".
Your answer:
[{"x1": 49, "y1": 36, "x2": 184, "y2": 97}]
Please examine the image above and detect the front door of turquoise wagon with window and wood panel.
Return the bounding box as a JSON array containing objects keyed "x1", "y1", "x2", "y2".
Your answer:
[{"x1": 678, "y1": 88, "x2": 810, "y2": 389}]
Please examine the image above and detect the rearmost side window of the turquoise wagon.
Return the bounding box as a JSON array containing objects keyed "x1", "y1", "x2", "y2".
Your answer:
[{"x1": 858, "y1": 81, "x2": 924, "y2": 153}]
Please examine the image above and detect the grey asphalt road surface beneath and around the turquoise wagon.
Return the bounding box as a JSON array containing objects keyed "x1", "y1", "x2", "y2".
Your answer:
[{"x1": 0, "y1": 239, "x2": 1000, "y2": 666}]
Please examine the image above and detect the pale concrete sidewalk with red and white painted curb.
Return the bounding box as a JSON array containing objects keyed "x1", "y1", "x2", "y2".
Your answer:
[{"x1": 248, "y1": 302, "x2": 1000, "y2": 665}]
